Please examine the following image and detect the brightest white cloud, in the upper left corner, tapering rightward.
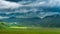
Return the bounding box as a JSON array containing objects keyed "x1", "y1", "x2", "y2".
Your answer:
[{"x1": 0, "y1": 0, "x2": 22, "y2": 9}]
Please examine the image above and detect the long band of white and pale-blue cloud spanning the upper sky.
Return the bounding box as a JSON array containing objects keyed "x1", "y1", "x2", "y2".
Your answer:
[{"x1": 0, "y1": 0, "x2": 60, "y2": 9}]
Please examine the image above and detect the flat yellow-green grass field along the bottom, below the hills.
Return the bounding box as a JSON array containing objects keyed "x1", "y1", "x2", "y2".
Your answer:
[{"x1": 0, "y1": 27, "x2": 60, "y2": 34}]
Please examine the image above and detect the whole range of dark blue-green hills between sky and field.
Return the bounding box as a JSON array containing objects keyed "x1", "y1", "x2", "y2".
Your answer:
[{"x1": 0, "y1": 15, "x2": 60, "y2": 27}]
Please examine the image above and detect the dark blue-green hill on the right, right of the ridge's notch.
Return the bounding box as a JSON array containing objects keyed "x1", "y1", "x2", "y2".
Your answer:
[{"x1": 41, "y1": 15, "x2": 60, "y2": 27}]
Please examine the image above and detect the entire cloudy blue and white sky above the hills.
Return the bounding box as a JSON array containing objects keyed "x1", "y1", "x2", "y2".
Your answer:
[{"x1": 0, "y1": 0, "x2": 60, "y2": 19}]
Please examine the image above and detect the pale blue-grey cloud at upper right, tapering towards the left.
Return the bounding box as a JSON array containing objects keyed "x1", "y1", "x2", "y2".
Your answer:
[{"x1": 26, "y1": 0, "x2": 60, "y2": 7}]
